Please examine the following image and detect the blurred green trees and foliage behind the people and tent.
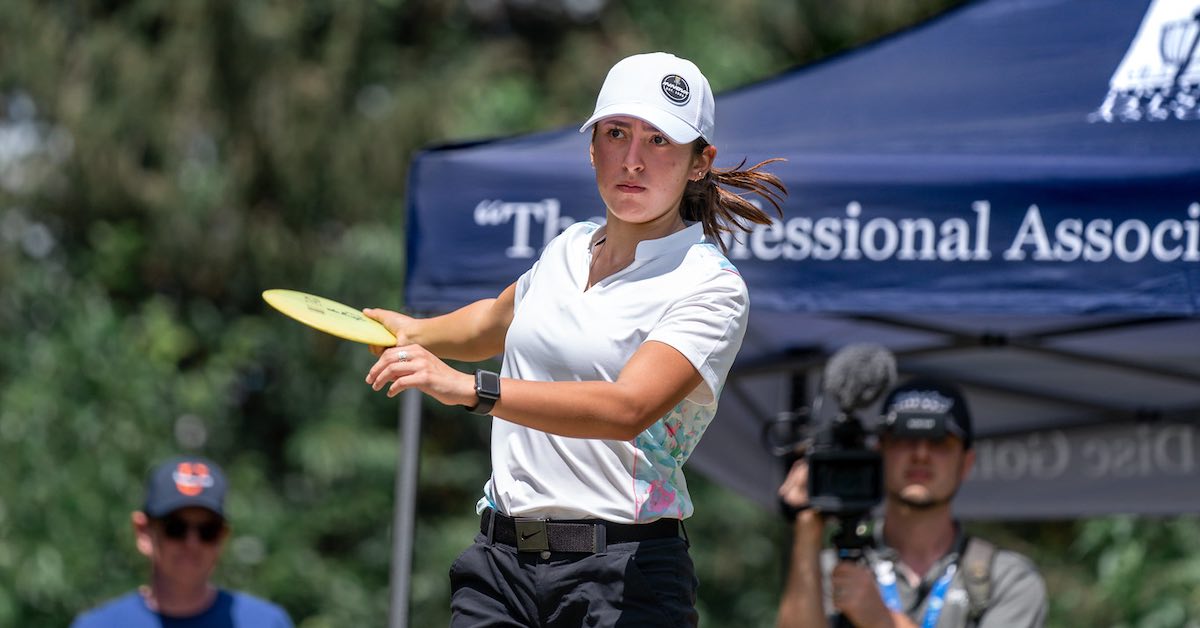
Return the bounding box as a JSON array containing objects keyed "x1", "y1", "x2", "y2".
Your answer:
[{"x1": 7, "y1": 0, "x2": 1200, "y2": 628}]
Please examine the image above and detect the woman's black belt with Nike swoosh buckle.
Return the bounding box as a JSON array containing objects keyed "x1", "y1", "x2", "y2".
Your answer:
[{"x1": 479, "y1": 508, "x2": 683, "y2": 554}]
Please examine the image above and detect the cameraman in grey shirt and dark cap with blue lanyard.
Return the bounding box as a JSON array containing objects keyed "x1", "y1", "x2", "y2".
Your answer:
[{"x1": 778, "y1": 379, "x2": 1046, "y2": 628}]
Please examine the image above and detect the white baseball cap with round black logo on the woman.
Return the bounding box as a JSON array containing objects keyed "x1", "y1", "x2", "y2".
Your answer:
[{"x1": 580, "y1": 53, "x2": 716, "y2": 144}]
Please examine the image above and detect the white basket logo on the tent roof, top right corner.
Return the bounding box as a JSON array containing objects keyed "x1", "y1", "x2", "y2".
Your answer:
[{"x1": 1087, "y1": 0, "x2": 1200, "y2": 122}]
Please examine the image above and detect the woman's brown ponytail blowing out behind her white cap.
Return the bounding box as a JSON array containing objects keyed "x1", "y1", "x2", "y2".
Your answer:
[{"x1": 679, "y1": 139, "x2": 787, "y2": 251}]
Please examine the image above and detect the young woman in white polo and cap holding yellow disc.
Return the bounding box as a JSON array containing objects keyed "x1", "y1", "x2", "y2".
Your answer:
[{"x1": 365, "y1": 53, "x2": 786, "y2": 626}]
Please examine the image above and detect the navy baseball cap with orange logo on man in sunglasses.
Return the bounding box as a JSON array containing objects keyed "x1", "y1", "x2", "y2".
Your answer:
[{"x1": 142, "y1": 456, "x2": 228, "y2": 519}]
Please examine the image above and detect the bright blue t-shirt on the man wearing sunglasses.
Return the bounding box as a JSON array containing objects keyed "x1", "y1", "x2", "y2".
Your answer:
[{"x1": 71, "y1": 590, "x2": 292, "y2": 628}]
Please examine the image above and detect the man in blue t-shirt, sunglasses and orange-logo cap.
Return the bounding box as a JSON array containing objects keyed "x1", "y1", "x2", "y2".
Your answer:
[{"x1": 72, "y1": 456, "x2": 292, "y2": 628}]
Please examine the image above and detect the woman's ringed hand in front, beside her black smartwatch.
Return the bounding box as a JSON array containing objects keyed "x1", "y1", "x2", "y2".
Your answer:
[{"x1": 367, "y1": 345, "x2": 475, "y2": 406}]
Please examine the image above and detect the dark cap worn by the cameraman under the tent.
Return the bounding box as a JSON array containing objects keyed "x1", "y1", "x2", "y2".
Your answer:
[{"x1": 880, "y1": 378, "x2": 974, "y2": 449}]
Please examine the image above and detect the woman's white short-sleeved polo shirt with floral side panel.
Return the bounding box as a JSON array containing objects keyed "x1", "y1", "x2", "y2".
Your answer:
[{"x1": 479, "y1": 222, "x2": 749, "y2": 524}]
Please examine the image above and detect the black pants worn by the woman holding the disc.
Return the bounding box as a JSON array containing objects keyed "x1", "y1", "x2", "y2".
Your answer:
[{"x1": 450, "y1": 534, "x2": 700, "y2": 628}]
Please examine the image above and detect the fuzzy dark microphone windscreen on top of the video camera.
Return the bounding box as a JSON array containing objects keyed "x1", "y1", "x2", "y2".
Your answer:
[{"x1": 824, "y1": 342, "x2": 896, "y2": 412}]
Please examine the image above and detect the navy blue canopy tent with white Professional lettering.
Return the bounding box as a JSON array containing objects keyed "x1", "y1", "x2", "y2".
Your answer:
[{"x1": 406, "y1": 0, "x2": 1200, "y2": 533}]
